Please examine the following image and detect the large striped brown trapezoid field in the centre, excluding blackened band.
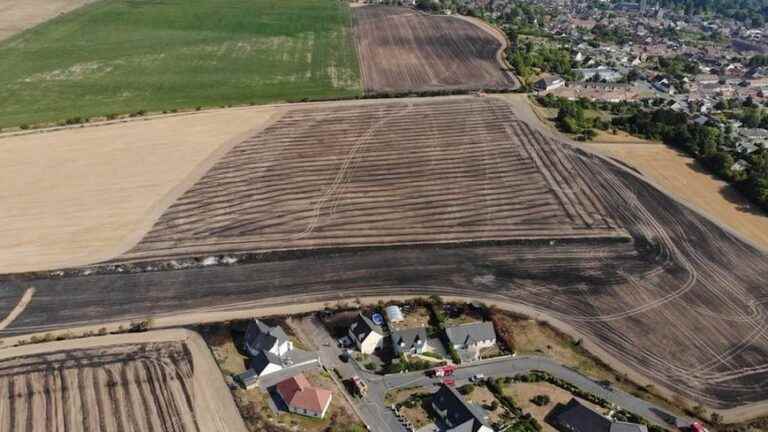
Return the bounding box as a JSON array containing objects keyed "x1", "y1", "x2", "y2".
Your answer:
[{"x1": 120, "y1": 98, "x2": 628, "y2": 259}]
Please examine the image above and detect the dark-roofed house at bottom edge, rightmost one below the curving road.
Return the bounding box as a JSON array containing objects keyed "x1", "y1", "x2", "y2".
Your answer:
[{"x1": 548, "y1": 399, "x2": 648, "y2": 432}]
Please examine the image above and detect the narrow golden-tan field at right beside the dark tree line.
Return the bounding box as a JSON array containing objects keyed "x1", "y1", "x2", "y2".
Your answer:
[{"x1": 583, "y1": 143, "x2": 768, "y2": 250}]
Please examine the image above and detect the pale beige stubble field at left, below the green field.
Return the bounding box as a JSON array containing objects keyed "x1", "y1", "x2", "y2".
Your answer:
[{"x1": 0, "y1": 108, "x2": 280, "y2": 273}]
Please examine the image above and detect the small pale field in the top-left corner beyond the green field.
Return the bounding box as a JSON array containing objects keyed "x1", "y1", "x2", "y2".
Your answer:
[{"x1": 0, "y1": 0, "x2": 97, "y2": 42}]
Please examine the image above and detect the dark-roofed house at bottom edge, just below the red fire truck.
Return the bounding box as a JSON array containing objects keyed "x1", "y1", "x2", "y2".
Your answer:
[{"x1": 432, "y1": 384, "x2": 494, "y2": 432}]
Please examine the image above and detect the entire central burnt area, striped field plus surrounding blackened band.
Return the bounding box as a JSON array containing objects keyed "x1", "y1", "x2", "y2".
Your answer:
[{"x1": 0, "y1": 98, "x2": 768, "y2": 414}]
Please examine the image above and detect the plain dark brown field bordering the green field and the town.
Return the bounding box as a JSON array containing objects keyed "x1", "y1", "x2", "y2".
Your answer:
[{"x1": 353, "y1": 6, "x2": 517, "y2": 94}]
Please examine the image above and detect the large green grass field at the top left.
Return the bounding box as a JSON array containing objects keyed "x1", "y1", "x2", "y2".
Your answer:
[{"x1": 0, "y1": 0, "x2": 362, "y2": 127}]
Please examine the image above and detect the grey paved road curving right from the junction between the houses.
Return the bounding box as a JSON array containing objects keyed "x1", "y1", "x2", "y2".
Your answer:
[{"x1": 364, "y1": 356, "x2": 688, "y2": 427}]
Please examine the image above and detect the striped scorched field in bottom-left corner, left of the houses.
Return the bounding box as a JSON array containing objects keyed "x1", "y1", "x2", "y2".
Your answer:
[{"x1": 0, "y1": 342, "x2": 201, "y2": 432}]
